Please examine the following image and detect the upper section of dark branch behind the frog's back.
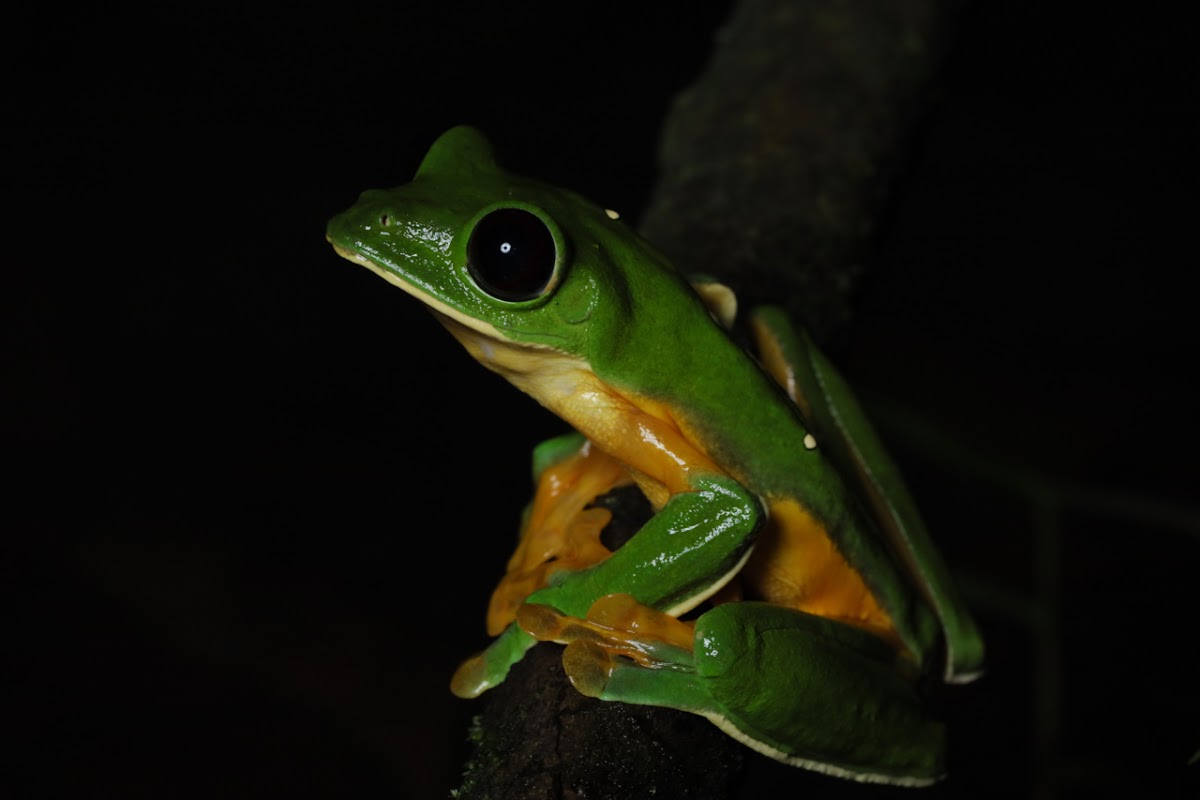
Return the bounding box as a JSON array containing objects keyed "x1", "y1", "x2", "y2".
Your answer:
[{"x1": 642, "y1": 0, "x2": 961, "y2": 342}]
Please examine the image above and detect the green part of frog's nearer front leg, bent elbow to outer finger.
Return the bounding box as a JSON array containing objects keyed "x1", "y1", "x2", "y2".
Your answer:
[{"x1": 451, "y1": 475, "x2": 763, "y2": 697}]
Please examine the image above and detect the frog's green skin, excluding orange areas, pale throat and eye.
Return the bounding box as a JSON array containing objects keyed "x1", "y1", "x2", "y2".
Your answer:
[{"x1": 328, "y1": 126, "x2": 983, "y2": 786}]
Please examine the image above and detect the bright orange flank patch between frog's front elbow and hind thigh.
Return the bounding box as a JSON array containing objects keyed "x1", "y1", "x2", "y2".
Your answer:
[{"x1": 742, "y1": 499, "x2": 901, "y2": 648}]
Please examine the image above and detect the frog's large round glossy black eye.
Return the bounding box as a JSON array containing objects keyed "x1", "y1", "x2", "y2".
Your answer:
[{"x1": 467, "y1": 209, "x2": 556, "y2": 301}]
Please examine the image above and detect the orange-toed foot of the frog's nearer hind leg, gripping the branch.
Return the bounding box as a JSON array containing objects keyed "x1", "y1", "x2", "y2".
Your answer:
[{"x1": 517, "y1": 595, "x2": 695, "y2": 702}]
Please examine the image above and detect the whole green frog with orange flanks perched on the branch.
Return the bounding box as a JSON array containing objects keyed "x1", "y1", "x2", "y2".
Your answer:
[{"x1": 326, "y1": 126, "x2": 983, "y2": 786}]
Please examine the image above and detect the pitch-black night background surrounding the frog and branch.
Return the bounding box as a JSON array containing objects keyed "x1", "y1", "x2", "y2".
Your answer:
[{"x1": 0, "y1": 1, "x2": 1200, "y2": 798}]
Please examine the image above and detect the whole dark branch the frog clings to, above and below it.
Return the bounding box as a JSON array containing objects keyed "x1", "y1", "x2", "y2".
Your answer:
[{"x1": 458, "y1": 0, "x2": 956, "y2": 800}]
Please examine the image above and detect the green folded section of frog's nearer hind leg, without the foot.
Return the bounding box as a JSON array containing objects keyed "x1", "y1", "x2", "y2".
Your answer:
[{"x1": 696, "y1": 602, "x2": 944, "y2": 786}]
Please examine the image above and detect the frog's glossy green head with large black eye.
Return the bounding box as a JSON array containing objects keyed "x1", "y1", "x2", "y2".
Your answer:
[{"x1": 326, "y1": 126, "x2": 670, "y2": 367}]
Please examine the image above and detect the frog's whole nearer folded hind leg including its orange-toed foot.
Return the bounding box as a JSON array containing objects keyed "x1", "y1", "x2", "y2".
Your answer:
[{"x1": 518, "y1": 597, "x2": 944, "y2": 786}]
